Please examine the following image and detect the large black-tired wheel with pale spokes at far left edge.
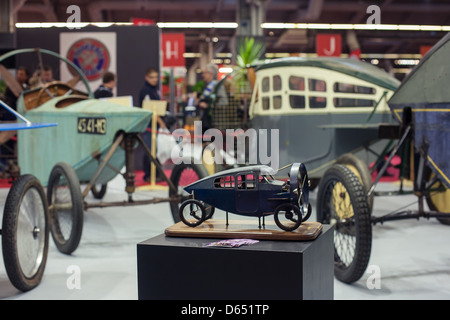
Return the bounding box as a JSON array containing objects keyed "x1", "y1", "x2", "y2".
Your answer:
[{"x1": 2, "y1": 174, "x2": 49, "y2": 291}]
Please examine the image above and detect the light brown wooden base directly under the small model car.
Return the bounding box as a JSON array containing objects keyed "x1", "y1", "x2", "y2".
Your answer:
[{"x1": 165, "y1": 219, "x2": 322, "y2": 241}]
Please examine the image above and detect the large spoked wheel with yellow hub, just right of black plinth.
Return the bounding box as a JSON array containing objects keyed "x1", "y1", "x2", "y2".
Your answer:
[{"x1": 317, "y1": 164, "x2": 372, "y2": 283}]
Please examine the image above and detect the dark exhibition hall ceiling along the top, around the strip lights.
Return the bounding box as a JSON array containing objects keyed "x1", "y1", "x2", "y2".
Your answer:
[{"x1": 13, "y1": 0, "x2": 450, "y2": 54}]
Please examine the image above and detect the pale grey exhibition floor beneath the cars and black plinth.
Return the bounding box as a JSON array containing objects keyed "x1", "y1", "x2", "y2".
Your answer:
[{"x1": 0, "y1": 172, "x2": 450, "y2": 300}]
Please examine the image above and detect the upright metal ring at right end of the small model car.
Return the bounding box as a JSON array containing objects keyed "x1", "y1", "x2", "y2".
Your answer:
[{"x1": 290, "y1": 163, "x2": 311, "y2": 221}]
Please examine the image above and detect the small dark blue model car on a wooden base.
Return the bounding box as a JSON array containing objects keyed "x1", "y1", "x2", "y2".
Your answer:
[{"x1": 179, "y1": 163, "x2": 311, "y2": 231}]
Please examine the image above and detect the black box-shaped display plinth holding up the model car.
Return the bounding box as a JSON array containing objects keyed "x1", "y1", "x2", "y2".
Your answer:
[{"x1": 137, "y1": 225, "x2": 334, "y2": 300}]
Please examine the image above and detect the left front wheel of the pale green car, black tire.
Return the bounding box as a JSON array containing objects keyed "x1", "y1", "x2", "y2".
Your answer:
[{"x1": 47, "y1": 162, "x2": 83, "y2": 254}]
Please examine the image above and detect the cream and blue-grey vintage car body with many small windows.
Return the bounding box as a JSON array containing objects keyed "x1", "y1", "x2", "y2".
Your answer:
[{"x1": 249, "y1": 57, "x2": 400, "y2": 184}]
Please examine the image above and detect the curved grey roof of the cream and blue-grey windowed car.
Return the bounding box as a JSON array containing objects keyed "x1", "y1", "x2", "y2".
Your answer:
[{"x1": 256, "y1": 57, "x2": 400, "y2": 90}]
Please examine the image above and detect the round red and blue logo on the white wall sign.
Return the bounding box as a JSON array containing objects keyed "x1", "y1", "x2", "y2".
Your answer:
[{"x1": 67, "y1": 39, "x2": 110, "y2": 81}]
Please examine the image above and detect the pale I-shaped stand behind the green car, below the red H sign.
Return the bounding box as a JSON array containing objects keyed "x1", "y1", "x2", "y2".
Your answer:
[{"x1": 139, "y1": 100, "x2": 168, "y2": 190}]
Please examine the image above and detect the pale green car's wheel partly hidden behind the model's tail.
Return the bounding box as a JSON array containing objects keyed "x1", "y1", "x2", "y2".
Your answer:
[{"x1": 169, "y1": 163, "x2": 208, "y2": 223}]
